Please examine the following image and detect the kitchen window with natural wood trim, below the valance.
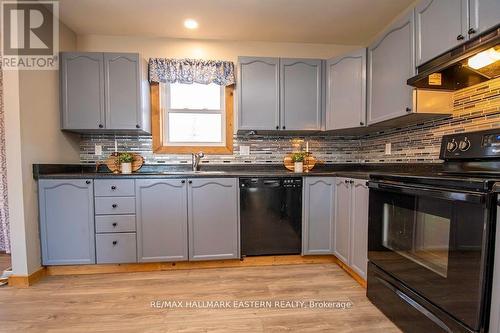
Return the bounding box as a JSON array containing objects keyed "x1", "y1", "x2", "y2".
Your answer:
[{"x1": 151, "y1": 83, "x2": 234, "y2": 154}]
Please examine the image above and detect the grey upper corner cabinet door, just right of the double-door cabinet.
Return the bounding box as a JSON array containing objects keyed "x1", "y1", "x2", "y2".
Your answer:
[{"x1": 326, "y1": 49, "x2": 366, "y2": 130}]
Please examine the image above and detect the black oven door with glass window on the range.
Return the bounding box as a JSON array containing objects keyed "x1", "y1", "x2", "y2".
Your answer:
[{"x1": 368, "y1": 181, "x2": 491, "y2": 330}]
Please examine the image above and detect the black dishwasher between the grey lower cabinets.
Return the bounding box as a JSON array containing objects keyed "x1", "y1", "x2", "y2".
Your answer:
[{"x1": 240, "y1": 177, "x2": 302, "y2": 256}]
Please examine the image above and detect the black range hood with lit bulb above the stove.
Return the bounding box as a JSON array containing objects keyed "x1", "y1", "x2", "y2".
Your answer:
[{"x1": 407, "y1": 26, "x2": 500, "y2": 91}]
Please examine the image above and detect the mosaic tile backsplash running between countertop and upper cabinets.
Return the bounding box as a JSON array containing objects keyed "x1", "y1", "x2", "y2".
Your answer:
[{"x1": 80, "y1": 78, "x2": 500, "y2": 164}]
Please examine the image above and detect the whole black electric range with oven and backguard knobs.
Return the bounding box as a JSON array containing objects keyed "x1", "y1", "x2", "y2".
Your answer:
[{"x1": 367, "y1": 129, "x2": 500, "y2": 332}]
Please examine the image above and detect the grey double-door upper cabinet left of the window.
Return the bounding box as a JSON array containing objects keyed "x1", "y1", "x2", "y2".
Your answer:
[{"x1": 60, "y1": 52, "x2": 151, "y2": 133}]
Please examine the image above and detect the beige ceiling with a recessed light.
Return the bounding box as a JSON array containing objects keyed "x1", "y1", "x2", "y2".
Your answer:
[{"x1": 60, "y1": 0, "x2": 413, "y2": 45}]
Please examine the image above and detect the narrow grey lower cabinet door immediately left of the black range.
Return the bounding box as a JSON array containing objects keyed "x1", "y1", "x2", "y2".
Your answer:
[{"x1": 349, "y1": 179, "x2": 369, "y2": 280}]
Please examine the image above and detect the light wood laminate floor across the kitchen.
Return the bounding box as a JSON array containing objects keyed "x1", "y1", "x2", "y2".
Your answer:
[{"x1": 0, "y1": 264, "x2": 400, "y2": 333}]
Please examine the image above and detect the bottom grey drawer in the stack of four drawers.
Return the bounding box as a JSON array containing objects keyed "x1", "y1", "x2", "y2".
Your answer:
[{"x1": 95, "y1": 233, "x2": 137, "y2": 264}]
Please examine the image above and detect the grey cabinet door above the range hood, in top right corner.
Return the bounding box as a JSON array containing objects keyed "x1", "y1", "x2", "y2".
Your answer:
[{"x1": 468, "y1": 0, "x2": 500, "y2": 38}]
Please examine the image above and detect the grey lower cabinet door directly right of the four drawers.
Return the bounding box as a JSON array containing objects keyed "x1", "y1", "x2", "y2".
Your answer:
[{"x1": 135, "y1": 179, "x2": 188, "y2": 262}]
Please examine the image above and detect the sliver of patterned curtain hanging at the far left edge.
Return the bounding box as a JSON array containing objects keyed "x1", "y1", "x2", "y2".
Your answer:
[{"x1": 0, "y1": 62, "x2": 10, "y2": 253}]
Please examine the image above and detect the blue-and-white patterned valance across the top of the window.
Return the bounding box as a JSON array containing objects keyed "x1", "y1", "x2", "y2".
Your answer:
[{"x1": 149, "y1": 58, "x2": 234, "y2": 86}]
